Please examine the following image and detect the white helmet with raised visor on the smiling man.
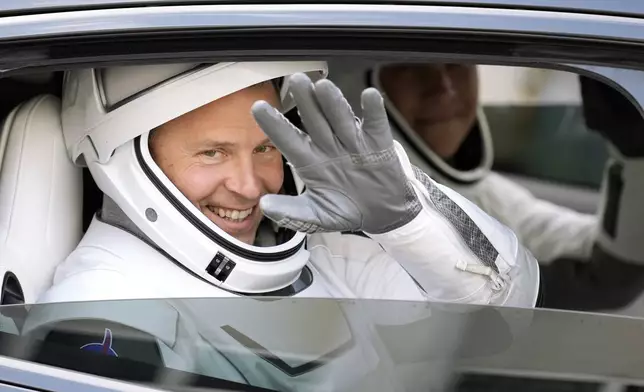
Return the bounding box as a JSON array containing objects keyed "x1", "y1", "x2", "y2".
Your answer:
[{"x1": 62, "y1": 61, "x2": 327, "y2": 294}]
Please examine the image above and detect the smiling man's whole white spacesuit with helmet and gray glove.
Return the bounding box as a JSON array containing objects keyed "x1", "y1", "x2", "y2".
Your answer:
[{"x1": 25, "y1": 62, "x2": 539, "y2": 390}]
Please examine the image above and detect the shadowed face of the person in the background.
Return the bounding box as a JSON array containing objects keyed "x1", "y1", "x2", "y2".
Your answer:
[{"x1": 380, "y1": 64, "x2": 478, "y2": 159}]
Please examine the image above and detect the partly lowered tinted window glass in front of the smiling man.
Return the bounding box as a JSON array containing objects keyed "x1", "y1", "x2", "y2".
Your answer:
[{"x1": 0, "y1": 297, "x2": 644, "y2": 392}]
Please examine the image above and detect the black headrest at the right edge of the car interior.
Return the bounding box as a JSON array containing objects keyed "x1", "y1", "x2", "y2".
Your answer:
[{"x1": 579, "y1": 76, "x2": 644, "y2": 158}]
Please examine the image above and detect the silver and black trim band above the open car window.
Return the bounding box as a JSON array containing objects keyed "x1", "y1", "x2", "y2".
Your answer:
[{"x1": 0, "y1": 2, "x2": 644, "y2": 75}]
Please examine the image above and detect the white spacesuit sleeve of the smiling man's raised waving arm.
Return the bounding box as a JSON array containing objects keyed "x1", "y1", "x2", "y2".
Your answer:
[{"x1": 367, "y1": 142, "x2": 540, "y2": 307}]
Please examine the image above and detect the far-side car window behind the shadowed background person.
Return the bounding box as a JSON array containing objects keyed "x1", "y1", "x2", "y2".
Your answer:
[{"x1": 479, "y1": 66, "x2": 608, "y2": 190}]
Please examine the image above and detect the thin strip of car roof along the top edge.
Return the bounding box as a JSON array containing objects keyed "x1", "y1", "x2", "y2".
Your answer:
[{"x1": 0, "y1": 0, "x2": 644, "y2": 17}]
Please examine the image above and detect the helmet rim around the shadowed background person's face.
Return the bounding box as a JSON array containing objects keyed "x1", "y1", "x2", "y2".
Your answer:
[{"x1": 367, "y1": 64, "x2": 494, "y2": 184}]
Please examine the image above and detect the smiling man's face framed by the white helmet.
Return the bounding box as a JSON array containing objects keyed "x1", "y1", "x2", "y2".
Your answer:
[{"x1": 150, "y1": 83, "x2": 284, "y2": 244}]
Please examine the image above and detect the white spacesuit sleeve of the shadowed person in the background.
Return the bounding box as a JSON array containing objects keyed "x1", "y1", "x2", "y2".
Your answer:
[{"x1": 474, "y1": 173, "x2": 598, "y2": 262}]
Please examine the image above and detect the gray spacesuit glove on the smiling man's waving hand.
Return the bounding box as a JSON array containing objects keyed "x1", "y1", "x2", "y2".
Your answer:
[{"x1": 252, "y1": 74, "x2": 422, "y2": 234}]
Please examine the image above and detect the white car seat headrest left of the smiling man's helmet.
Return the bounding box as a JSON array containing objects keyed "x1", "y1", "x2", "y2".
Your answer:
[{"x1": 0, "y1": 95, "x2": 83, "y2": 303}]
